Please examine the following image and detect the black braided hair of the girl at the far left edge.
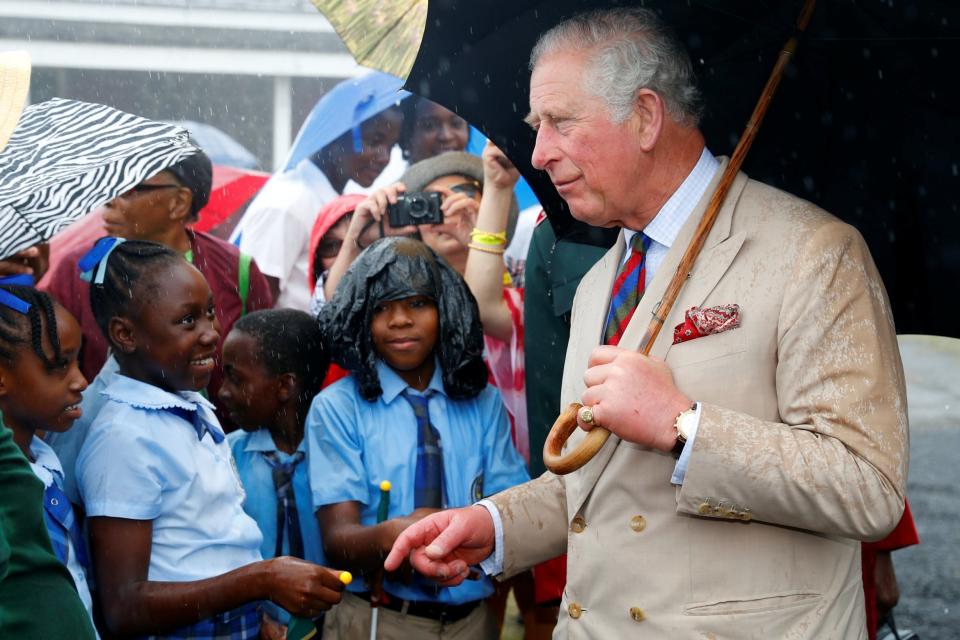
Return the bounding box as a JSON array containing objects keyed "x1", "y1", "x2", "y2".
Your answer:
[{"x1": 0, "y1": 285, "x2": 66, "y2": 371}]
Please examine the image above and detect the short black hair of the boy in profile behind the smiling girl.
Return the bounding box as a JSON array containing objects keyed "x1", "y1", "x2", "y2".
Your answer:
[{"x1": 233, "y1": 309, "x2": 330, "y2": 398}]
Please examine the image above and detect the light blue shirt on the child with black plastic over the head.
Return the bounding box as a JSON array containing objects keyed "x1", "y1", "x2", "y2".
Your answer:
[{"x1": 306, "y1": 362, "x2": 529, "y2": 604}]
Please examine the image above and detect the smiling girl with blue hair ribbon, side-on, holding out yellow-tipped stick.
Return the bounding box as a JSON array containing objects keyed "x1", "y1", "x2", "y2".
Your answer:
[{"x1": 77, "y1": 238, "x2": 342, "y2": 639}]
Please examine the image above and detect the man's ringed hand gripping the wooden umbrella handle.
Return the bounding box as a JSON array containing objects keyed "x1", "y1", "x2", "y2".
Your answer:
[{"x1": 577, "y1": 345, "x2": 692, "y2": 451}]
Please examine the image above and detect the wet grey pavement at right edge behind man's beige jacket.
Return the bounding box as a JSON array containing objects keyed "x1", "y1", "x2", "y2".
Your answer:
[{"x1": 893, "y1": 336, "x2": 960, "y2": 640}]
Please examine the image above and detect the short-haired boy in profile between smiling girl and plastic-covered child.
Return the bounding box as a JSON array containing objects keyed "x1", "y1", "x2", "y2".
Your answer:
[{"x1": 219, "y1": 309, "x2": 329, "y2": 625}]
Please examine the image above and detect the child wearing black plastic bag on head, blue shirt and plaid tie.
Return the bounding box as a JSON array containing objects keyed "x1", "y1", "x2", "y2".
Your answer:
[{"x1": 306, "y1": 238, "x2": 527, "y2": 640}]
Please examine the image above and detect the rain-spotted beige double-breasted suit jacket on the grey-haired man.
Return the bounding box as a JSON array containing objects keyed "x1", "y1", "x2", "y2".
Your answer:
[{"x1": 492, "y1": 161, "x2": 908, "y2": 640}]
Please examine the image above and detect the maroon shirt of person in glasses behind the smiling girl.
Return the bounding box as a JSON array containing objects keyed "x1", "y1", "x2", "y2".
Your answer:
[{"x1": 41, "y1": 230, "x2": 273, "y2": 431}]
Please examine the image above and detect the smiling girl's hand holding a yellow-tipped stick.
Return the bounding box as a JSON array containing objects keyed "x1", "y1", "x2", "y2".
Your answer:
[{"x1": 266, "y1": 556, "x2": 344, "y2": 618}]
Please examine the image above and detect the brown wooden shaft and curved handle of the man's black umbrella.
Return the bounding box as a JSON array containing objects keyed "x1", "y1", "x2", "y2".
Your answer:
[{"x1": 543, "y1": 0, "x2": 816, "y2": 475}]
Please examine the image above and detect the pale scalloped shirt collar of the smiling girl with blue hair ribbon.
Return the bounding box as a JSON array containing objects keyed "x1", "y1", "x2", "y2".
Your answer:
[{"x1": 100, "y1": 373, "x2": 225, "y2": 444}]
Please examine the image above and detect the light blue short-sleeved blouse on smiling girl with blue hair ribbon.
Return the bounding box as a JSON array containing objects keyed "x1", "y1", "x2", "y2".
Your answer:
[{"x1": 77, "y1": 373, "x2": 263, "y2": 582}]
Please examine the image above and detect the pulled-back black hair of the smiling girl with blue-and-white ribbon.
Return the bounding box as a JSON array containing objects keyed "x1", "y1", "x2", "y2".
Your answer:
[{"x1": 90, "y1": 240, "x2": 184, "y2": 344}]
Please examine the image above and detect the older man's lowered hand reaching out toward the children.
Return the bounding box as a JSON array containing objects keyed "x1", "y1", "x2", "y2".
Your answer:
[{"x1": 383, "y1": 505, "x2": 494, "y2": 586}]
